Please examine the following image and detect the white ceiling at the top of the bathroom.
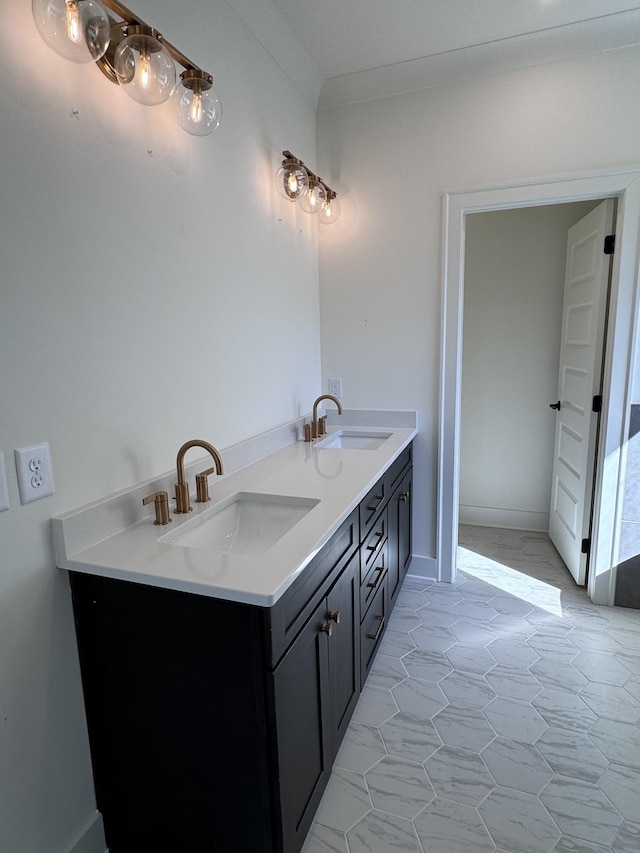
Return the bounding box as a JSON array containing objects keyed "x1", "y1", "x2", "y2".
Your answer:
[{"x1": 233, "y1": 0, "x2": 640, "y2": 108}]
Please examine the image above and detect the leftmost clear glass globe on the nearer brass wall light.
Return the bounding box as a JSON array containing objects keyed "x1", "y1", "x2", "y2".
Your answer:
[{"x1": 31, "y1": 0, "x2": 111, "y2": 62}]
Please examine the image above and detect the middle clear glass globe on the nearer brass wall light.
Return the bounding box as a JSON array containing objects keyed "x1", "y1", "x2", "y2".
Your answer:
[{"x1": 113, "y1": 25, "x2": 176, "y2": 107}]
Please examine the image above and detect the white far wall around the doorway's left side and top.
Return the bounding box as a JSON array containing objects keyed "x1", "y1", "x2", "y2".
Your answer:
[{"x1": 318, "y1": 48, "x2": 640, "y2": 558}]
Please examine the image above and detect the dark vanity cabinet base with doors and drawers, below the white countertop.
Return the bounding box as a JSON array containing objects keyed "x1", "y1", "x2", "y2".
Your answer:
[{"x1": 70, "y1": 446, "x2": 412, "y2": 853}]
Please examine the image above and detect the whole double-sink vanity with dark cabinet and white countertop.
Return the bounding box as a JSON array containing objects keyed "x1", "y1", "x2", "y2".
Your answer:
[{"x1": 54, "y1": 411, "x2": 416, "y2": 853}]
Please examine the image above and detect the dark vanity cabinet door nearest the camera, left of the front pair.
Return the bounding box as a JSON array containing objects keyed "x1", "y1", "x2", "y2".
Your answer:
[{"x1": 273, "y1": 599, "x2": 333, "y2": 853}]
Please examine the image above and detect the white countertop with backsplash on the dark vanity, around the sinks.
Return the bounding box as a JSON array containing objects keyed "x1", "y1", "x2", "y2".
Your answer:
[{"x1": 53, "y1": 418, "x2": 417, "y2": 606}]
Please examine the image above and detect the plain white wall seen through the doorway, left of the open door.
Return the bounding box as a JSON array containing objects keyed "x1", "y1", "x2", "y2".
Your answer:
[{"x1": 460, "y1": 202, "x2": 594, "y2": 531}]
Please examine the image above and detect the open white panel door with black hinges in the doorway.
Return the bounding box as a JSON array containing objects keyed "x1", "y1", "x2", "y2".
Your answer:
[{"x1": 549, "y1": 200, "x2": 614, "y2": 585}]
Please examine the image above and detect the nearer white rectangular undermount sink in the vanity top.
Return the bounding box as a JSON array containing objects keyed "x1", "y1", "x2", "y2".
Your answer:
[{"x1": 159, "y1": 492, "x2": 319, "y2": 554}]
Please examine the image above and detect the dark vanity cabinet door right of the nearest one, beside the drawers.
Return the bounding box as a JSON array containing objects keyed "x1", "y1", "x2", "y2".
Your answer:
[{"x1": 326, "y1": 555, "x2": 360, "y2": 760}]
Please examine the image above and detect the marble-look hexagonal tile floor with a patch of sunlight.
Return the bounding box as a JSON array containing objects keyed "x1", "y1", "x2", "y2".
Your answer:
[{"x1": 303, "y1": 527, "x2": 640, "y2": 853}]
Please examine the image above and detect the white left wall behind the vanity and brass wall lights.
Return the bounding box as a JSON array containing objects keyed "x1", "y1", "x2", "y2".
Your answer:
[{"x1": 0, "y1": 0, "x2": 320, "y2": 853}]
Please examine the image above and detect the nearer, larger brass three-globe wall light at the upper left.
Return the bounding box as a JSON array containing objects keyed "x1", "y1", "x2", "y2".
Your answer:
[{"x1": 31, "y1": 0, "x2": 222, "y2": 136}]
